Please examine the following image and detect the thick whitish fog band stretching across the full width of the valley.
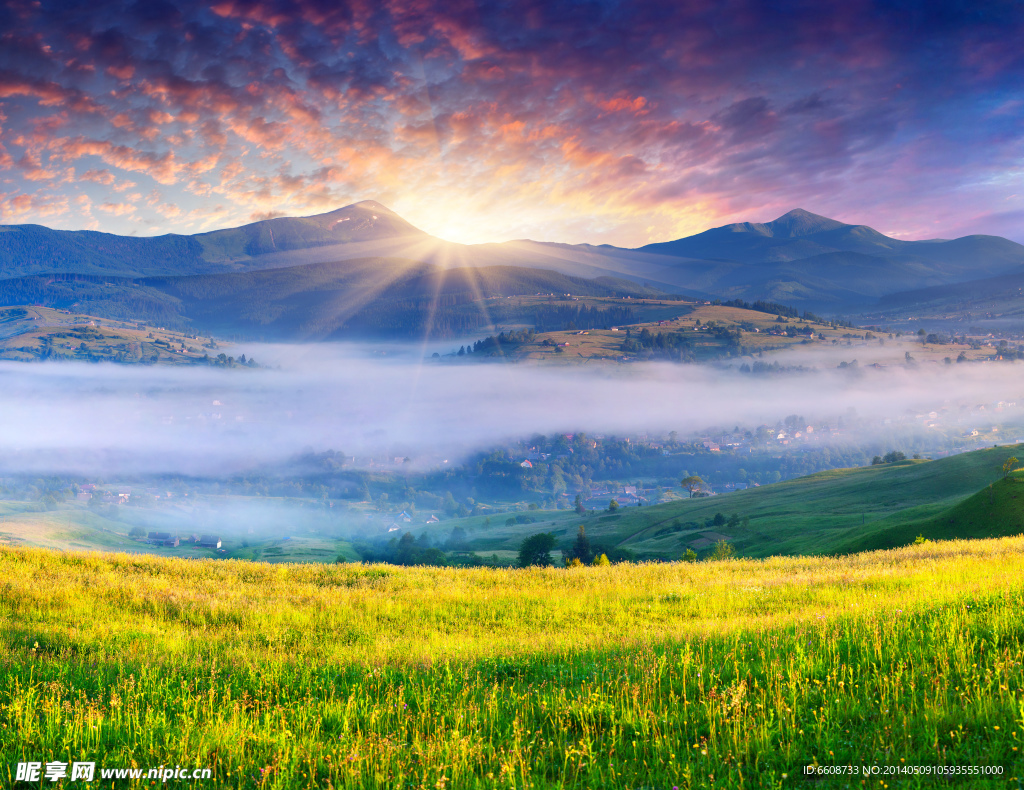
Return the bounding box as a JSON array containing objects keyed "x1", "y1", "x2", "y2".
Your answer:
[{"x1": 0, "y1": 344, "x2": 1024, "y2": 476}]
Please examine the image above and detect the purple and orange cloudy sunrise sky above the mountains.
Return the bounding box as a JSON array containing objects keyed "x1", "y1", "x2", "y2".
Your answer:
[{"x1": 0, "y1": 0, "x2": 1024, "y2": 247}]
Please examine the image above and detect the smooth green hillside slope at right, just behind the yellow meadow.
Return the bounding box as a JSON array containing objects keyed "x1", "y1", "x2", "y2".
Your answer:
[{"x1": 491, "y1": 445, "x2": 1024, "y2": 558}]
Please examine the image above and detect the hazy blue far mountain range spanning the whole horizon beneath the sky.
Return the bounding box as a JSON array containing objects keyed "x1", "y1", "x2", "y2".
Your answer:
[{"x1": 0, "y1": 201, "x2": 1024, "y2": 313}]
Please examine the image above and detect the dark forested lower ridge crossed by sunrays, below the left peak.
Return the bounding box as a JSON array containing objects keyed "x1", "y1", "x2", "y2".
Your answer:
[{"x1": 0, "y1": 258, "x2": 664, "y2": 340}]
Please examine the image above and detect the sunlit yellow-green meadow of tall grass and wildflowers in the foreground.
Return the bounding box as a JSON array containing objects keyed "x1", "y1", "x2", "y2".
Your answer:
[{"x1": 0, "y1": 536, "x2": 1024, "y2": 790}]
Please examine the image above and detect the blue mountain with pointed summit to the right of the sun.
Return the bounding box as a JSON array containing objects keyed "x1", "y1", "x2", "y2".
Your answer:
[{"x1": 519, "y1": 209, "x2": 1024, "y2": 310}]
